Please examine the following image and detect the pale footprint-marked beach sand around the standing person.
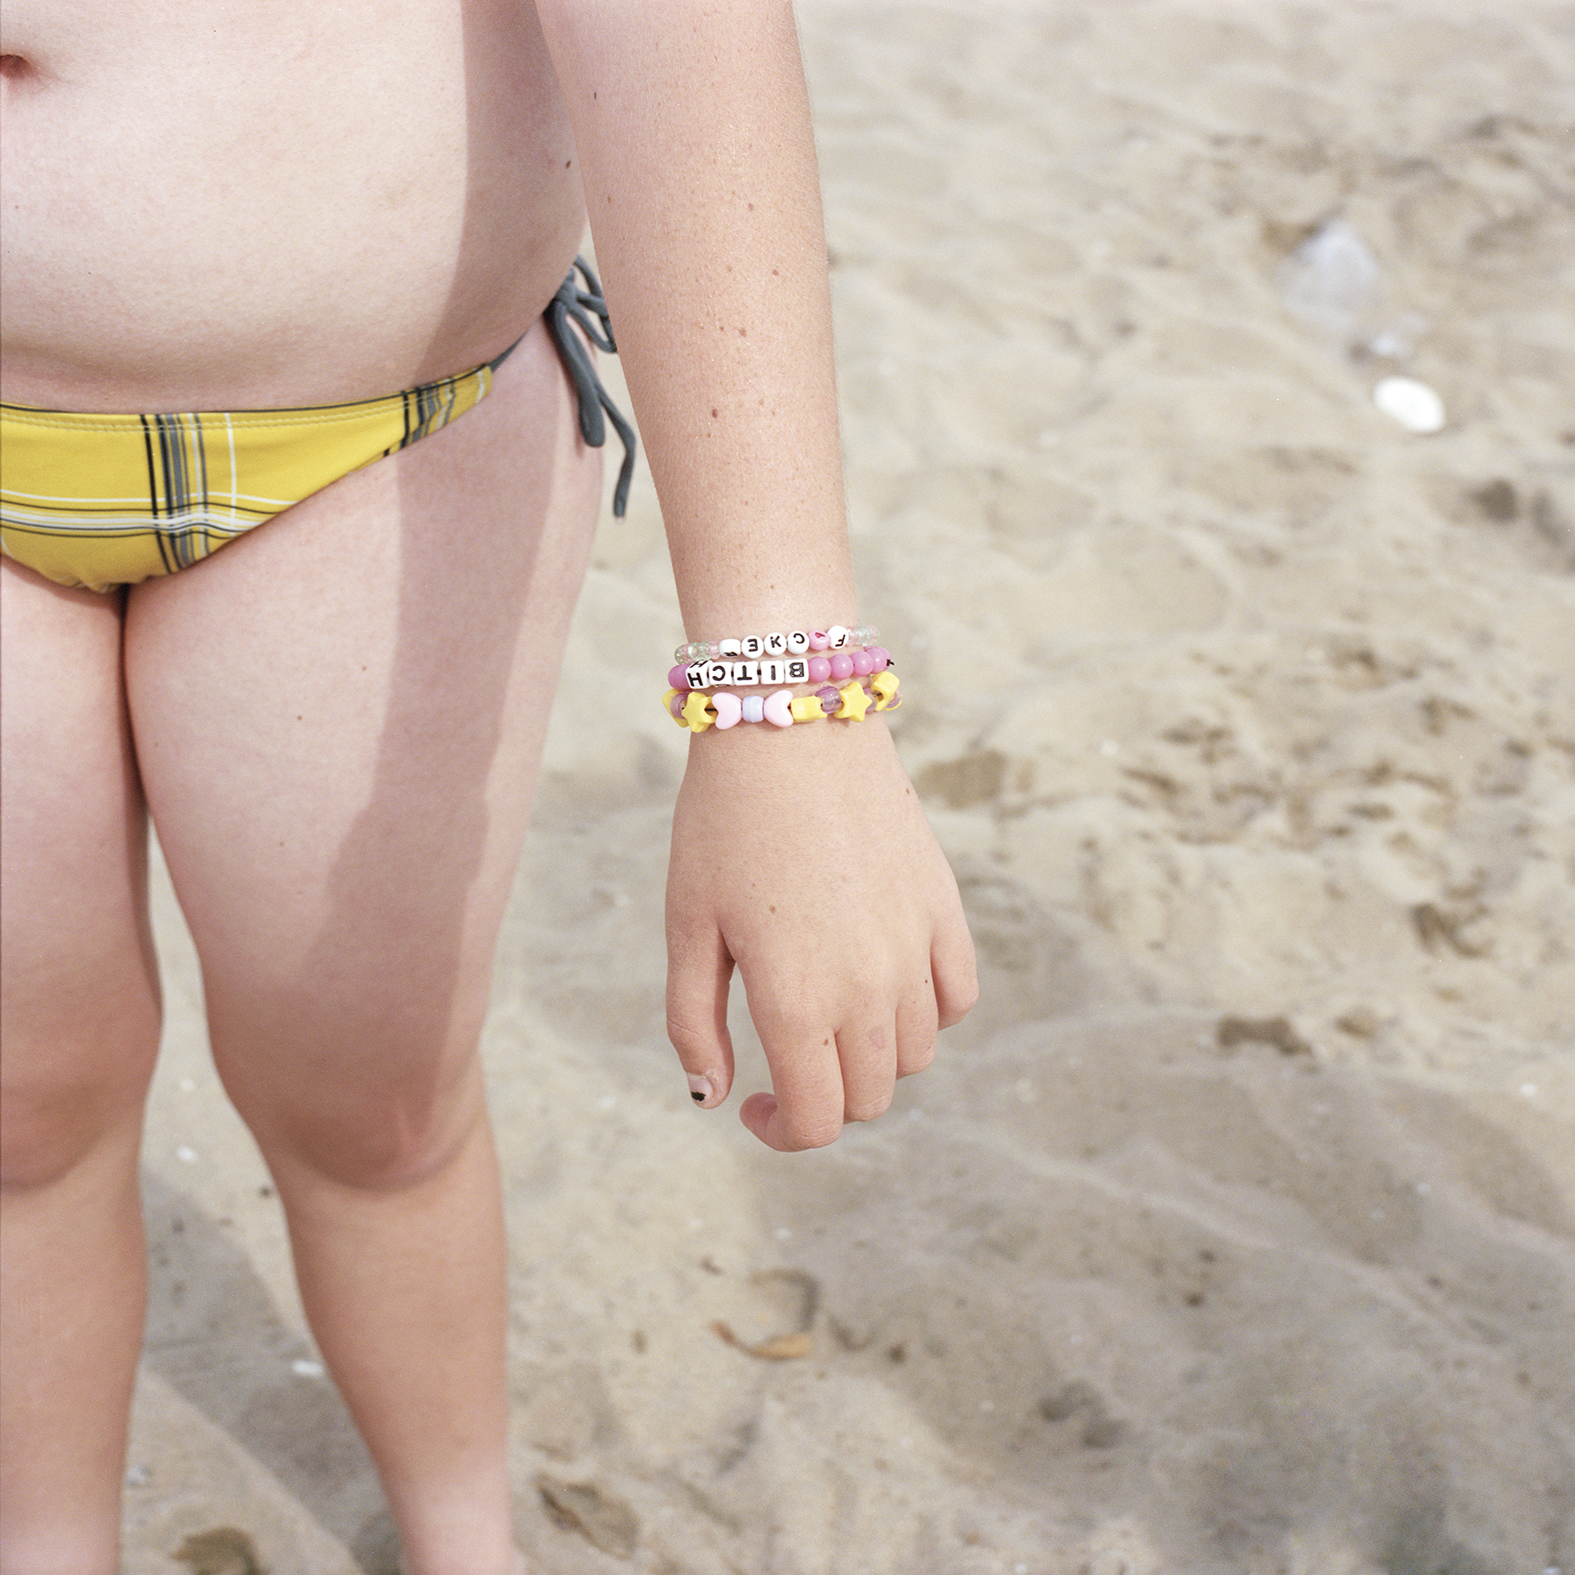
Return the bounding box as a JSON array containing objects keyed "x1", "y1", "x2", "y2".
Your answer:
[{"x1": 126, "y1": 0, "x2": 1575, "y2": 1575}]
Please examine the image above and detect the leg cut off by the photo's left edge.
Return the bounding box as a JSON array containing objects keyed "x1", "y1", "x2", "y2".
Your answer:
[{"x1": 0, "y1": 559, "x2": 159, "y2": 1575}]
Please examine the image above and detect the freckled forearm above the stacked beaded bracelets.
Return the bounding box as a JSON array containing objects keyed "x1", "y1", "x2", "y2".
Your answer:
[{"x1": 539, "y1": 0, "x2": 857, "y2": 639}]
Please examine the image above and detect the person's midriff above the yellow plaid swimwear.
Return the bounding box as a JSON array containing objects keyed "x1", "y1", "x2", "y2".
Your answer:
[{"x1": 0, "y1": 0, "x2": 584, "y2": 411}]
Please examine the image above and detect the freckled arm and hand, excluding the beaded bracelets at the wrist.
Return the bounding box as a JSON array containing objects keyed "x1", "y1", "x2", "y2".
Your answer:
[{"x1": 539, "y1": 0, "x2": 977, "y2": 1148}]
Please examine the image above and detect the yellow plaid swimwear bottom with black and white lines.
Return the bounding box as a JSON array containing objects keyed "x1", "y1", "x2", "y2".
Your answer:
[{"x1": 0, "y1": 351, "x2": 507, "y2": 591}]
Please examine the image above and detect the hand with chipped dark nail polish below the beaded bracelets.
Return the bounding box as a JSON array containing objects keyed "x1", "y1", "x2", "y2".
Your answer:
[{"x1": 668, "y1": 717, "x2": 978, "y2": 1151}]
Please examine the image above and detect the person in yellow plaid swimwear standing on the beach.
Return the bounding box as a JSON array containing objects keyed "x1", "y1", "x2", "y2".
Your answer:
[{"x1": 0, "y1": 0, "x2": 975, "y2": 1575}]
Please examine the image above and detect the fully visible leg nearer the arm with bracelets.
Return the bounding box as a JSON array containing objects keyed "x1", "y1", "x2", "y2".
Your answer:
[{"x1": 126, "y1": 324, "x2": 600, "y2": 1575}]
